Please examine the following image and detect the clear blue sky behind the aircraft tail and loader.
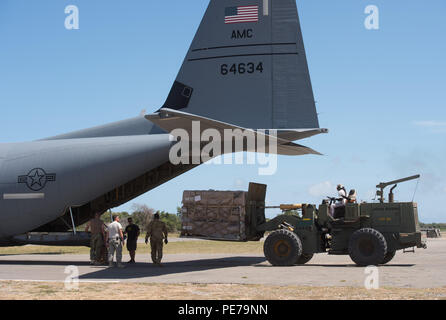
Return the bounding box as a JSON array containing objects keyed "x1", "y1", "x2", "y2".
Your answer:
[{"x1": 0, "y1": 0, "x2": 446, "y2": 222}]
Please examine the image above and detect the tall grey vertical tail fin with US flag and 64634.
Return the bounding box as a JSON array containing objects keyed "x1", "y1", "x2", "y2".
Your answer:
[{"x1": 163, "y1": 0, "x2": 319, "y2": 131}]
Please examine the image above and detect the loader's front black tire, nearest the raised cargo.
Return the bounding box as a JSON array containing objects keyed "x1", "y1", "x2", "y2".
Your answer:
[{"x1": 263, "y1": 229, "x2": 302, "y2": 266}]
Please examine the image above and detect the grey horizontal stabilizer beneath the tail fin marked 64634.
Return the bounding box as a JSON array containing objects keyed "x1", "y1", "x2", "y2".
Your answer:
[{"x1": 146, "y1": 108, "x2": 320, "y2": 155}]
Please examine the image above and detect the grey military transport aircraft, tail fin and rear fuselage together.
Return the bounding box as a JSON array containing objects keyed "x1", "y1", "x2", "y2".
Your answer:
[{"x1": 0, "y1": 0, "x2": 326, "y2": 245}]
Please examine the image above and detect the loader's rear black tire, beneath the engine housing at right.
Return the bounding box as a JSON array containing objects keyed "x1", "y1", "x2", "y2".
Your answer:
[{"x1": 348, "y1": 228, "x2": 387, "y2": 266}]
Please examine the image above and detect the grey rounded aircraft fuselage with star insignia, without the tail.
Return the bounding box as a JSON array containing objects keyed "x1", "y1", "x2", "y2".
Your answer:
[{"x1": 0, "y1": 134, "x2": 172, "y2": 238}]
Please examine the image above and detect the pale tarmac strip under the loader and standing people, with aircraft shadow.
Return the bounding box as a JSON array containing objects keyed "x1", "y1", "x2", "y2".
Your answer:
[{"x1": 0, "y1": 238, "x2": 446, "y2": 288}]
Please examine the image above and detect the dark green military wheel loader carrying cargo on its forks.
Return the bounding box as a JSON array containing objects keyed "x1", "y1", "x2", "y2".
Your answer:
[{"x1": 181, "y1": 176, "x2": 426, "y2": 266}]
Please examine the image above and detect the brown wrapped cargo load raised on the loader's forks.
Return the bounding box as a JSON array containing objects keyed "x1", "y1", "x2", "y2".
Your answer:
[{"x1": 181, "y1": 183, "x2": 266, "y2": 241}]
